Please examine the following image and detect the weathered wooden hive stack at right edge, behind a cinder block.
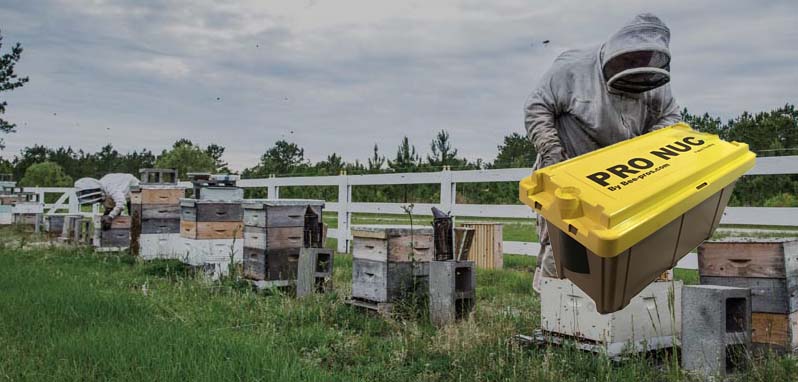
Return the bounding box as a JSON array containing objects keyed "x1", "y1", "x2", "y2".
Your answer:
[{"x1": 698, "y1": 238, "x2": 798, "y2": 351}]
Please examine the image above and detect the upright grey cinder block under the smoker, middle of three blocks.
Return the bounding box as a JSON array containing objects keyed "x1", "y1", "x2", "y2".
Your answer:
[{"x1": 429, "y1": 260, "x2": 477, "y2": 326}]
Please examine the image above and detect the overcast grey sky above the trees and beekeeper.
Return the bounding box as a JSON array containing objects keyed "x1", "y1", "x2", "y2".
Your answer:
[{"x1": 0, "y1": 0, "x2": 798, "y2": 170}]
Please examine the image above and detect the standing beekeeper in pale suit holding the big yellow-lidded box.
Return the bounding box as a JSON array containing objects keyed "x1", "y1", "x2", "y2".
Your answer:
[{"x1": 525, "y1": 13, "x2": 680, "y2": 290}]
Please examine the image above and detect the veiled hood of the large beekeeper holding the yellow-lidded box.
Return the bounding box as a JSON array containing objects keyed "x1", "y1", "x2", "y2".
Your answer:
[{"x1": 601, "y1": 13, "x2": 671, "y2": 93}]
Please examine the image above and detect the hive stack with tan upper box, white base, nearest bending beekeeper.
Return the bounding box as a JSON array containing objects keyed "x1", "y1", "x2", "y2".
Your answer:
[{"x1": 130, "y1": 169, "x2": 185, "y2": 260}]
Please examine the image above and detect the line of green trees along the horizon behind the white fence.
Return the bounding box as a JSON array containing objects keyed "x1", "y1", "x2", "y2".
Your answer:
[{"x1": 0, "y1": 104, "x2": 798, "y2": 206}]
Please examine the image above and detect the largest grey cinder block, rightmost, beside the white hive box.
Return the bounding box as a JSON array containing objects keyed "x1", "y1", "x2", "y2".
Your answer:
[{"x1": 682, "y1": 285, "x2": 751, "y2": 377}]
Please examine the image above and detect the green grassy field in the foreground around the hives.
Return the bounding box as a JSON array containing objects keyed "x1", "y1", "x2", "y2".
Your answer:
[{"x1": 0, "y1": 229, "x2": 798, "y2": 382}]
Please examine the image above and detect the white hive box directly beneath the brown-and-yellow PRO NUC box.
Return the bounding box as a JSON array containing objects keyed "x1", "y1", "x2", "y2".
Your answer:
[{"x1": 540, "y1": 277, "x2": 682, "y2": 355}]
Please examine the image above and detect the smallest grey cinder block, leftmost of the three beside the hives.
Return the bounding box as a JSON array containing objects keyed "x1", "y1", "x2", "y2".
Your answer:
[{"x1": 296, "y1": 248, "x2": 333, "y2": 297}]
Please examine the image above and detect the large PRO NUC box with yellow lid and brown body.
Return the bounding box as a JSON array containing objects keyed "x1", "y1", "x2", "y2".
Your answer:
[{"x1": 519, "y1": 123, "x2": 756, "y2": 313}]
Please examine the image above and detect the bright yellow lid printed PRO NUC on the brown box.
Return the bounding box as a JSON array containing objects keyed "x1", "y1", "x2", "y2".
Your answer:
[{"x1": 519, "y1": 123, "x2": 756, "y2": 257}]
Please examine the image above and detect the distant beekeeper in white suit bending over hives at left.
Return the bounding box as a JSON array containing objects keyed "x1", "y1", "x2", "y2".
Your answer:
[{"x1": 75, "y1": 174, "x2": 139, "y2": 230}]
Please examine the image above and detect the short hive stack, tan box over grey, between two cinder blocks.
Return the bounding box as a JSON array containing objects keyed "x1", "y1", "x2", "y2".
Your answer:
[{"x1": 352, "y1": 226, "x2": 433, "y2": 310}]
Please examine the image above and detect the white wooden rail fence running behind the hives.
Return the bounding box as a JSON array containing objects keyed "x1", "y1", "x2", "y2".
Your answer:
[{"x1": 21, "y1": 156, "x2": 798, "y2": 268}]
